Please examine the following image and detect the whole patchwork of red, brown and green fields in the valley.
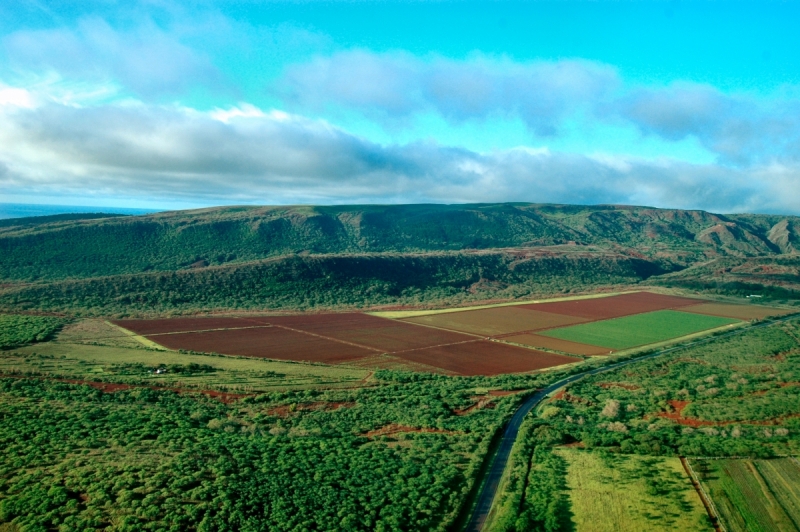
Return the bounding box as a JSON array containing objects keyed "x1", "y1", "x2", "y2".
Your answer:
[{"x1": 113, "y1": 292, "x2": 782, "y2": 375}]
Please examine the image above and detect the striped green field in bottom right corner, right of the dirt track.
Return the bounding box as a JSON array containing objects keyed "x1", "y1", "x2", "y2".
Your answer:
[{"x1": 691, "y1": 458, "x2": 800, "y2": 532}]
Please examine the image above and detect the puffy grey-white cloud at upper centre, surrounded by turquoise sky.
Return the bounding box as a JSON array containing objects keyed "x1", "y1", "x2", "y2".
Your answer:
[{"x1": 276, "y1": 50, "x2": 619, "y2": 135}]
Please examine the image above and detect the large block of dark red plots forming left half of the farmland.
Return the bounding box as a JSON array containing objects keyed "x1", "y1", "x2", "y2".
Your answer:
[{"x1": 115, "y1": 311, "x2": 580, "y2": 375}]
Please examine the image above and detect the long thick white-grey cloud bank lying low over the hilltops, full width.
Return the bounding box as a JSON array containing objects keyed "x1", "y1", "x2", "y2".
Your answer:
[{"x1": 0, "y1": 98, "x2": 800, "y2": 213}]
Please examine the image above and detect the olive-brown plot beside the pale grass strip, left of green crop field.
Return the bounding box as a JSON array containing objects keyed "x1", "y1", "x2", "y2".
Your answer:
[{"x1": 403, "y1": 307, "x2": 586, "y2": 336}]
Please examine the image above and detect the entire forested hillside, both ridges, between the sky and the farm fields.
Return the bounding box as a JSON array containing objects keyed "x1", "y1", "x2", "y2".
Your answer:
[{"x1": 0, "y1": 204, "x2": 800, "y2": 312}]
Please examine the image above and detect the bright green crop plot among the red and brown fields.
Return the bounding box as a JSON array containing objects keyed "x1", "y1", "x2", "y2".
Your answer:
[{"x1": 539, "y1": 310, "x2": 740, "y2": 349}]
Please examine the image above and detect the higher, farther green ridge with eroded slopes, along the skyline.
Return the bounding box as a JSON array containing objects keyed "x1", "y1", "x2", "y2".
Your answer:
[{"x1": 0, "y1": 203, "x2": 798, "y2": 281}]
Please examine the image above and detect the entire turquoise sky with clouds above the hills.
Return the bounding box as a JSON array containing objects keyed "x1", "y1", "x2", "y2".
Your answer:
[{"x1": 0, "y1": 0, "x2": 800, "y2": 214}]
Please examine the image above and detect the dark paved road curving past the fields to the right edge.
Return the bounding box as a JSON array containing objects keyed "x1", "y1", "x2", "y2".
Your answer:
[{"x1": 465, "y1": 314, "x2": 797, "y2": 532}]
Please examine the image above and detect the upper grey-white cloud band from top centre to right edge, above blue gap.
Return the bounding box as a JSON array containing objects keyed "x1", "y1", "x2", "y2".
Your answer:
[{"x1": 276, "y1": 50, "x2": 800, "y2": 165}]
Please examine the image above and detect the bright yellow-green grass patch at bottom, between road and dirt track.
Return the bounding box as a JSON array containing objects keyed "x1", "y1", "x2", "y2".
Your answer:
[{"x1": 554, "y1": 448, "x2": 713, "y2": 532}]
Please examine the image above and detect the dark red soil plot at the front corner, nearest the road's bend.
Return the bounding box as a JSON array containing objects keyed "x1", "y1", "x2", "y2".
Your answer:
[{"x1": 394, "y1": 340, "x2": 580, "y2": 375}]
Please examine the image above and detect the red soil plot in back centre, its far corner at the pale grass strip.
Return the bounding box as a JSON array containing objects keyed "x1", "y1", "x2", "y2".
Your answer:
[{"x1": 258, "y1": 313, "x2": 475, "y2": 353}]
